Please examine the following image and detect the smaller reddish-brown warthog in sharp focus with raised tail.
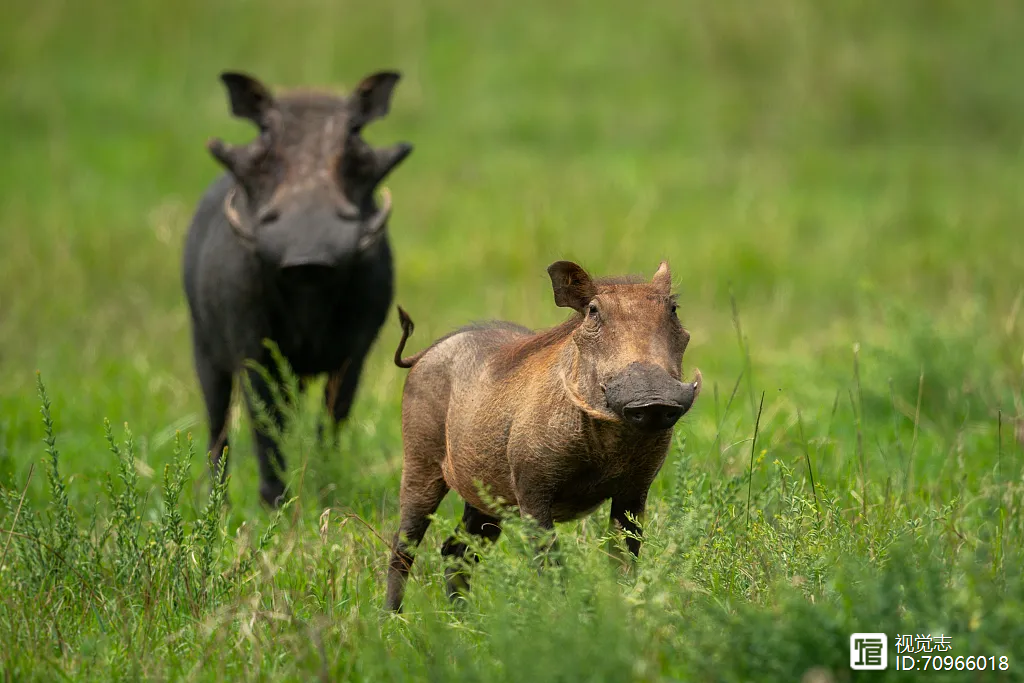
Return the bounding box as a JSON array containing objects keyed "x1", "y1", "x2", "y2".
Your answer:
[{"x1": 387, "y1": 261, "x2": 700, "y2": 610}]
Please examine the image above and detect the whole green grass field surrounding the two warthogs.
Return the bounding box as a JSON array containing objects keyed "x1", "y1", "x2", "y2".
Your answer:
[{"x1": 0, "y1": 0, "x2": 1024, "y2": 682}]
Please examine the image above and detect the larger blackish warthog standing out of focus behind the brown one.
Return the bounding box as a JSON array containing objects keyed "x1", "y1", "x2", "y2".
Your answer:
[{"x1": 183, "y1": 72, "x2": 412, "y2": 505}]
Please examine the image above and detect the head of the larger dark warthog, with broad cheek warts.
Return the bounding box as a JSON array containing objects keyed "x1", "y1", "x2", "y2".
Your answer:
[{"x1": 208, "y1": 72, "x2": 413, "y2": 282}]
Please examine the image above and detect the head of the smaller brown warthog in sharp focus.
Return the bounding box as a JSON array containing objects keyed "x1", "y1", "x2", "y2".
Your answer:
[{"x1": 548, "y1": 261, "x2": 701, "y2": 431}]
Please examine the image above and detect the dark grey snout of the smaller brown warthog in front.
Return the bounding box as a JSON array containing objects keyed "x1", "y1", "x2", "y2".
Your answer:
[{"x1": 604, "y1": 362, "x2": 700, "y2": 431}]
